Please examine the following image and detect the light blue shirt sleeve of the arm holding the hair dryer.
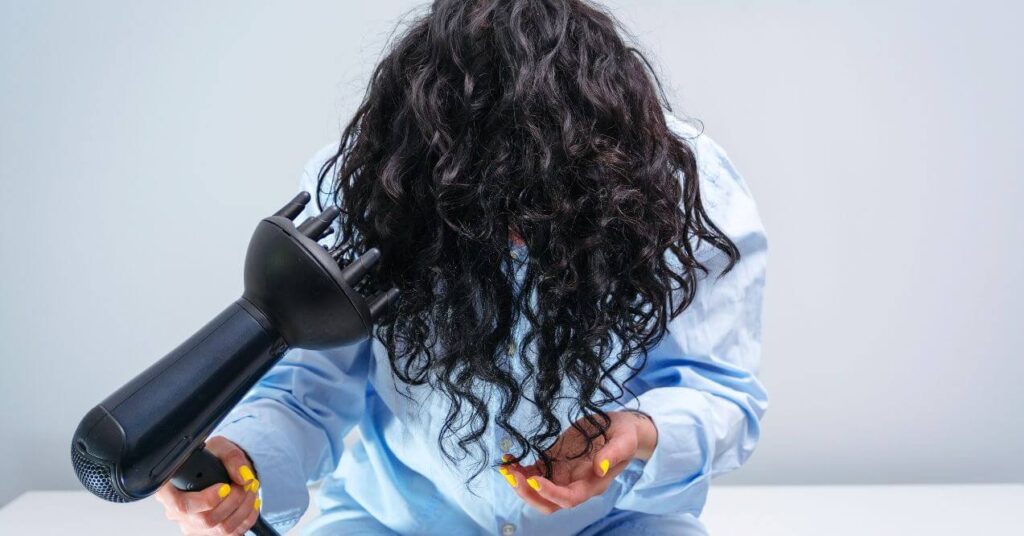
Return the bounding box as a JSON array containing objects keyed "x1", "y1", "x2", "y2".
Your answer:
[{"x1": 212, "y1": 140, "x2": 371, "y2": 531}]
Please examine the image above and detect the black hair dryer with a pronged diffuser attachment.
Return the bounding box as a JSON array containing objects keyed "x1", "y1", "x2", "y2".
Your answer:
[{"x1": 71, "y1": 193, "x2": 398, "y2": 536}]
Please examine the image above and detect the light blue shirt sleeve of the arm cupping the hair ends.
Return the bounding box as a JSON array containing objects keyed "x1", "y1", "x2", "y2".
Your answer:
[{"x1": 616, "y1": 126, "x2": 767, "y2": 516}]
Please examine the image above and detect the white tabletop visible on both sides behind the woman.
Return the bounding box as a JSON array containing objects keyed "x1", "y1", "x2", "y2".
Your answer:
[{"x1": 0, "y1": 484, "x2": 1024, "y2": 536}]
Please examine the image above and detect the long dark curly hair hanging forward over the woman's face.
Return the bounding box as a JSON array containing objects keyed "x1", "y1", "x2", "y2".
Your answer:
[{"x1": 318, "y1": 0, "x2": 739, "y2": 475}]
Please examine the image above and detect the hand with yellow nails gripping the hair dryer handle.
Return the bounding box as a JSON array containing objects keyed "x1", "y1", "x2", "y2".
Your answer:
[{"x1": 156, "y1": 436, "x2": 260, "y2": 536}]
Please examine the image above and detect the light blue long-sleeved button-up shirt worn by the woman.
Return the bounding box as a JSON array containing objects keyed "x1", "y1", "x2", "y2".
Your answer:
[{"x1": 214, "y1": 116, "x2": 767, "y2": 535}]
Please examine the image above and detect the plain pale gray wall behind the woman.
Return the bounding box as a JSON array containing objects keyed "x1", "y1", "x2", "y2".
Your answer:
[{"x1": 0, "y1": 0, "x2": 1024, "y2": 504}]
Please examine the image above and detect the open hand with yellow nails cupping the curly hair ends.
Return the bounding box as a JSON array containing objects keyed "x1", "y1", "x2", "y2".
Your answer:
[{"x1": 498, "y1": 411, "x2": 657, "y2": 513}]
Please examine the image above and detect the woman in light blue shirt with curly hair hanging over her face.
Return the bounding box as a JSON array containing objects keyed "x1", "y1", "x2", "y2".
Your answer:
[{"x1": 158, "y1": 0, "x2": 766, "y2": 535}]
